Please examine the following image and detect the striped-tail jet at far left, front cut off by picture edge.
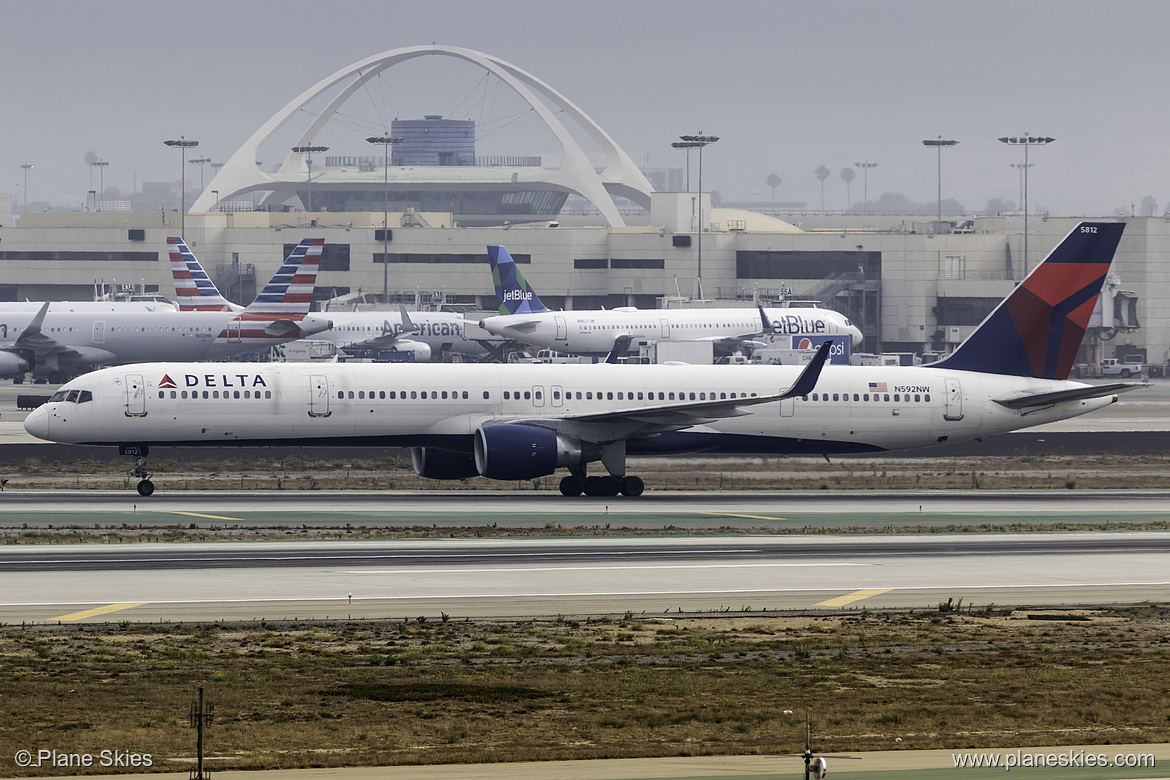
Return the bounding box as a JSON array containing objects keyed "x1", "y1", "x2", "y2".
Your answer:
[{"x1": 0, "y1": 239, "x2": 330, "y2": 382}]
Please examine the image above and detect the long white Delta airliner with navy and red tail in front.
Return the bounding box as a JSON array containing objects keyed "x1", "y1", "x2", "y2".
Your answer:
[{"x1": 25, "y1": 222, "x2": 1140, "y2": 496}]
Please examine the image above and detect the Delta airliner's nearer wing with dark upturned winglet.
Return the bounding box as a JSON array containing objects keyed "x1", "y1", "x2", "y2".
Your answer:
[{"x1": 511, "y1": 341, "x2": 832, "y2": 442}]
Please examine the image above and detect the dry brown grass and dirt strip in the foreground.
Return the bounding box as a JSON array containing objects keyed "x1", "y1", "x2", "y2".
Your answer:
[{"x1": 0, "y1": 605, "x2": 1170, "y2": 774}]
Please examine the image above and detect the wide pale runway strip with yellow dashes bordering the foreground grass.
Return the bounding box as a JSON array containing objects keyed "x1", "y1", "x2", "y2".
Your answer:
[{"x1": 0, "y1": 532, "x2": 1170, "y2": 623}]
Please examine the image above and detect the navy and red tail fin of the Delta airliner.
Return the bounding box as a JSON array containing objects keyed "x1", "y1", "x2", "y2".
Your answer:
[{"x1": 932, "y1": 222, "x2": 1126, "y2": 379}]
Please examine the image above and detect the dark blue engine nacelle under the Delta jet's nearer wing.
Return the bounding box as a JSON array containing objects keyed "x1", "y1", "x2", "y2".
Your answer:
[{"x1": 475, "y1": 424, "x2": 584, "y2": 479}]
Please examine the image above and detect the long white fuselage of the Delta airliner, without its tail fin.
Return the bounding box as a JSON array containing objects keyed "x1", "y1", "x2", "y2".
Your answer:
[{"x1": 26, "y1": 363, "x2": 1116, "y2": 455}]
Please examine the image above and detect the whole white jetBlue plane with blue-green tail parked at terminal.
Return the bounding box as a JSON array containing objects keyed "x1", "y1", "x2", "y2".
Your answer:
[{"x1": 480, "y1": 247, "x2": 861, "y2": 356}]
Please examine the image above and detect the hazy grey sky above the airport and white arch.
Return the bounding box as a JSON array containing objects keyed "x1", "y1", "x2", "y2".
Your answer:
[{"x1": 0, "y1": 0, "x2": 1170, "y2": 215}]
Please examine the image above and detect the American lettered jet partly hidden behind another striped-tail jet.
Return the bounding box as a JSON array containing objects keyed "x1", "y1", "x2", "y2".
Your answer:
[{"x1": 166, "y1": 237, "x2": 490, "y2": 363}]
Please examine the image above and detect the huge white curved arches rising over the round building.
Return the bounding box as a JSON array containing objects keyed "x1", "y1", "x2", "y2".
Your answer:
[{"x1": 191, "y1": 46, "x2": 653, "y2": 226}]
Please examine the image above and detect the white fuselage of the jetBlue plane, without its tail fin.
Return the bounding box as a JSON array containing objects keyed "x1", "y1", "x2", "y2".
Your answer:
[{"x1": 480, "y1": 309, "x2": 861, "y2": 354}]
